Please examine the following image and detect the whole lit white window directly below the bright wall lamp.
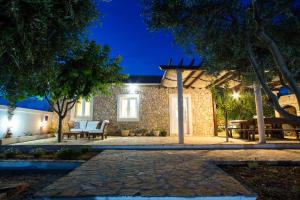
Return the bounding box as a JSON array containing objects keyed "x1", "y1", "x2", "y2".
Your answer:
[{"x1": 118, "y1": 94, "x2": 139, "y2": 121}]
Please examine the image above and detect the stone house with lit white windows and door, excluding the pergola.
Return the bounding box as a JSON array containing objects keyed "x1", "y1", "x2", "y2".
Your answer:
[{"x1": 61, "y1": 76, "x2": 216, "y2": 136}]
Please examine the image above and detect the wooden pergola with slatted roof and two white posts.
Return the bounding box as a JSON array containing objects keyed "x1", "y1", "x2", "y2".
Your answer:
[{"x1": 160, "y1": 59, "x2": 265, "y2": 144}]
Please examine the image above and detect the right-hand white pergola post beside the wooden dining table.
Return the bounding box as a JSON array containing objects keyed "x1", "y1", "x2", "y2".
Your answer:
[{"x1": 253, "y1": 83, "x2": 266, "y2": 144}]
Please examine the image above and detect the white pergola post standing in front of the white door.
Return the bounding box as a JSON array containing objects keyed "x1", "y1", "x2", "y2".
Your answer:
[{"x1": 176, "y1": 69, "x2": 184, "y2": 144}]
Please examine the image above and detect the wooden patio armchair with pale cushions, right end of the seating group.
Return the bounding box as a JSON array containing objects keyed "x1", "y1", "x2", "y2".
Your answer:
[{"x1": 86, "y1": 120, "x2": 109, "y2": 140}]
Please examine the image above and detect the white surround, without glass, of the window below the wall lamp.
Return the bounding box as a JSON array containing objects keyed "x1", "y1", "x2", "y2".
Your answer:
[{"x1": 117, "y1": 94, "x2": 140, "y2": 122}]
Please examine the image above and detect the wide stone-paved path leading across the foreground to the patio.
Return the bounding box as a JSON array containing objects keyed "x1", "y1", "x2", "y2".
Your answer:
[{"x1": 36, "y1": 150, "x2": 253, "y2": 197}]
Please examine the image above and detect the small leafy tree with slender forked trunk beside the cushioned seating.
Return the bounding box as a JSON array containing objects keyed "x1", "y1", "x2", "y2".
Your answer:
[{"x1": 44, "y1": 41, "x2": 126, "y2": 142}]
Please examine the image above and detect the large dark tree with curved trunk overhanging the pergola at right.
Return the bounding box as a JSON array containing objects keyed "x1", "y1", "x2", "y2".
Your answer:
[{"x1": 144, "y1": 0, "x2": 300, "y2": 121}]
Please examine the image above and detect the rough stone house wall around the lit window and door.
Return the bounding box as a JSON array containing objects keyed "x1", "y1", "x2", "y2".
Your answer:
[{"x1": 93, "y1": 85, "x2": 215, "y2": 136}]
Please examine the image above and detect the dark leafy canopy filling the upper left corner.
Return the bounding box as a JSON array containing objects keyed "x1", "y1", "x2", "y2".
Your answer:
[{"x1": 0, "y1": 0, "x2": 98, "y2": 105}]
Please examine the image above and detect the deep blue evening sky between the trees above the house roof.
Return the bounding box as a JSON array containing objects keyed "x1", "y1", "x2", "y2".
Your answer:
[{"x1": 89, "y1": 0, "x2": 199, "y2": 75}]
